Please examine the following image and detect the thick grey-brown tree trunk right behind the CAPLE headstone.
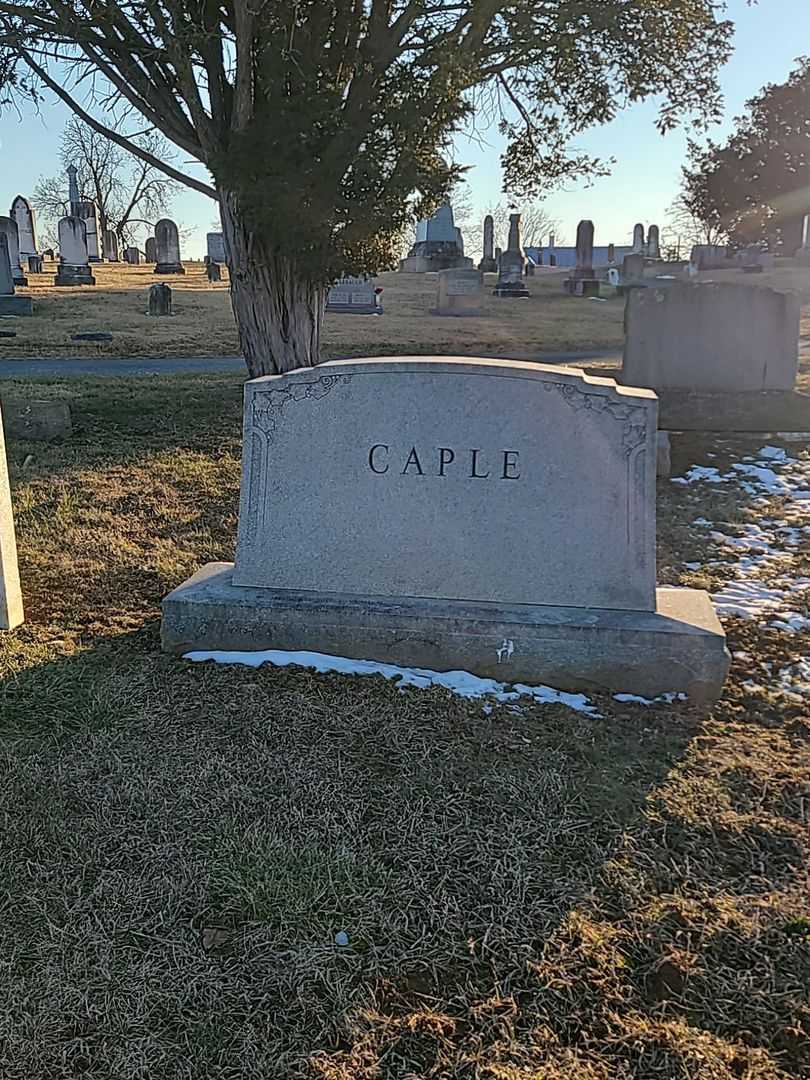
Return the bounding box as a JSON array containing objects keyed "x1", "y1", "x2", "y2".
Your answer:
[{"x1": 219, "y1": 191, "x2": 326, "y2": 379}]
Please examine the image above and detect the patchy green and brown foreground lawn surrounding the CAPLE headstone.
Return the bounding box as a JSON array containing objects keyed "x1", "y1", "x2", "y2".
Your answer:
[{"x1": 0, "y1": 373, "x2": 810, "y2": 1080}]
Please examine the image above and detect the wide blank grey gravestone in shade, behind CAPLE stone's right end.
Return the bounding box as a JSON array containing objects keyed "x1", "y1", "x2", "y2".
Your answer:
[{"x1": 621, "y1": 282, "x2": 810, "y2": 393}]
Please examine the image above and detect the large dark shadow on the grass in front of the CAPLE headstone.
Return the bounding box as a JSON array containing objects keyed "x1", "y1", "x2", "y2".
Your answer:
[{"x1": 0, "y1": 624, "x2": 717, "y2": 1080}]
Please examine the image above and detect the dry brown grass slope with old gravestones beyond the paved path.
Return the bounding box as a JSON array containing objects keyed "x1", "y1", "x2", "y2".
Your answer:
[{"x1": 7, "y1": 262, "x2": 810, "y2": 357}]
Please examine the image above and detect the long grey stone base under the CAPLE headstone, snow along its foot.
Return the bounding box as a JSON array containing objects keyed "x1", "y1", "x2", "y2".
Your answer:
[{"x1": 161, "y1": 563, "x2": 729, "y2": 706}]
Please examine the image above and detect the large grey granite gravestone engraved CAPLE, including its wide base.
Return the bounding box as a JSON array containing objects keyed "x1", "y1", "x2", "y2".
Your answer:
[{"x1": 162, "y1": 356, "x2": 728, "y2": 701}]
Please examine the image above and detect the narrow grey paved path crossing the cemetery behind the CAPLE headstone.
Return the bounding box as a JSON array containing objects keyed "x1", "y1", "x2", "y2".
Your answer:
[{"x1": 0, "y1": 350, "x2": 621, "y2": 379}]
